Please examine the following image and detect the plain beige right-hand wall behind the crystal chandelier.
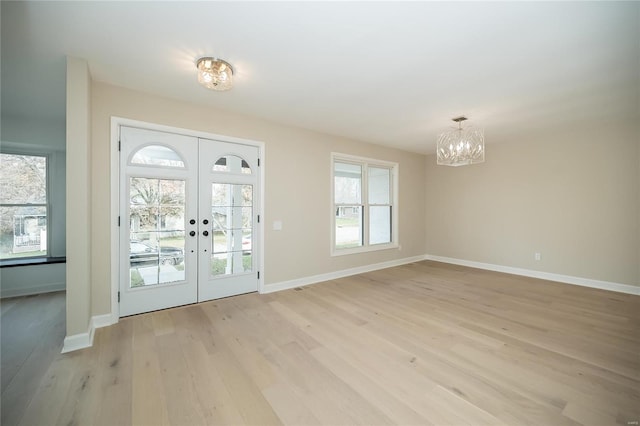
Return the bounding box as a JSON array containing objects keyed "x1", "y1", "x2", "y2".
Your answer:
[{"x1": 426, "y1": 120, "x2": 640, "y2": 286}]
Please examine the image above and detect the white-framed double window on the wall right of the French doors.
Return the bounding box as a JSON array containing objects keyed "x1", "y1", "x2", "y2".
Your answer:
[{"x1": 331, "y1": 153, "x2": 398, "y2": 255}]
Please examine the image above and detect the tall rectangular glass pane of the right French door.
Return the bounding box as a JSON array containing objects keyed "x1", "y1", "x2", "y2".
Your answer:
[{"x1": 210, "y1": 183, "x2": 253, "y2": 276}]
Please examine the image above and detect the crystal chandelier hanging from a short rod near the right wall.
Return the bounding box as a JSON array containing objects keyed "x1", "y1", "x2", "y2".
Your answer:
[{"x1": 437, "y1": 117, "x2": 484, "y2": 166}]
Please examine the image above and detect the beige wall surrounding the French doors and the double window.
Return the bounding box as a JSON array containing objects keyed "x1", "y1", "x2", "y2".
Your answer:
[{"x1": 91, "y1": 83, "x2": 425, "y2": 315}]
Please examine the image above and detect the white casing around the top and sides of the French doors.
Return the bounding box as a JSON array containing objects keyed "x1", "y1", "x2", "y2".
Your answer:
[{"x1": 109, "y1": 116, "x2": 266, "y2": 324}]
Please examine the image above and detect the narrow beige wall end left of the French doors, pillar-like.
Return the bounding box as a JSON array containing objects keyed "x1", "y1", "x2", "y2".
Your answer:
[{"x1": 67, "y1": 58, "x2": 92, "y2": 337}]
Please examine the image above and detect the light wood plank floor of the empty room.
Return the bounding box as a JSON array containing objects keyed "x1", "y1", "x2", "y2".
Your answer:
[{"x1": 2, "y1": 262, "x2": 640, "y2": 425}]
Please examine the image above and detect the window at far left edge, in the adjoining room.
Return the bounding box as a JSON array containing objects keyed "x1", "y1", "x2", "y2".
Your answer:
[{"x1": 0, "y1": 153, "x2": 49, "y2": 259}]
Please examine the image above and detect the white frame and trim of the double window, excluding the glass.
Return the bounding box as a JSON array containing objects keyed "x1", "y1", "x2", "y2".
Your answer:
[{"x1": 329, "y1": 152, "x2": 400, "y2": 257}]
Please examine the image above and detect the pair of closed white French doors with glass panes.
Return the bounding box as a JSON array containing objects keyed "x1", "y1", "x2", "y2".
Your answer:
[{"x1": 119, "y1": 126, "x2": 260, "y2": 316}]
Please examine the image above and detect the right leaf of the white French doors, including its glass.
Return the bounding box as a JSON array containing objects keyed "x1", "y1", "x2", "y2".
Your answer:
[{"x1": 198, "y1": 139, "x2": 258, "y2": 301}]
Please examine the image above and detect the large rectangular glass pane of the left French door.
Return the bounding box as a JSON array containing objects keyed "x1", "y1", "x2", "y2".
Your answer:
[{"x1": 129, "y1": 177, "x2": 185, "y2": 287}]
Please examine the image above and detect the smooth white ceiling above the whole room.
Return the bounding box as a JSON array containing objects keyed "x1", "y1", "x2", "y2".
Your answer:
[{"x1": 1, "y1": 1, "x2": 640, "y2": 153}]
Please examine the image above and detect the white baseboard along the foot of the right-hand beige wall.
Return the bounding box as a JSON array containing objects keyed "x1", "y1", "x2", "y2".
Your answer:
[{"x1": 424, "y1": 254, "x2": 640, "y2": 295}]
